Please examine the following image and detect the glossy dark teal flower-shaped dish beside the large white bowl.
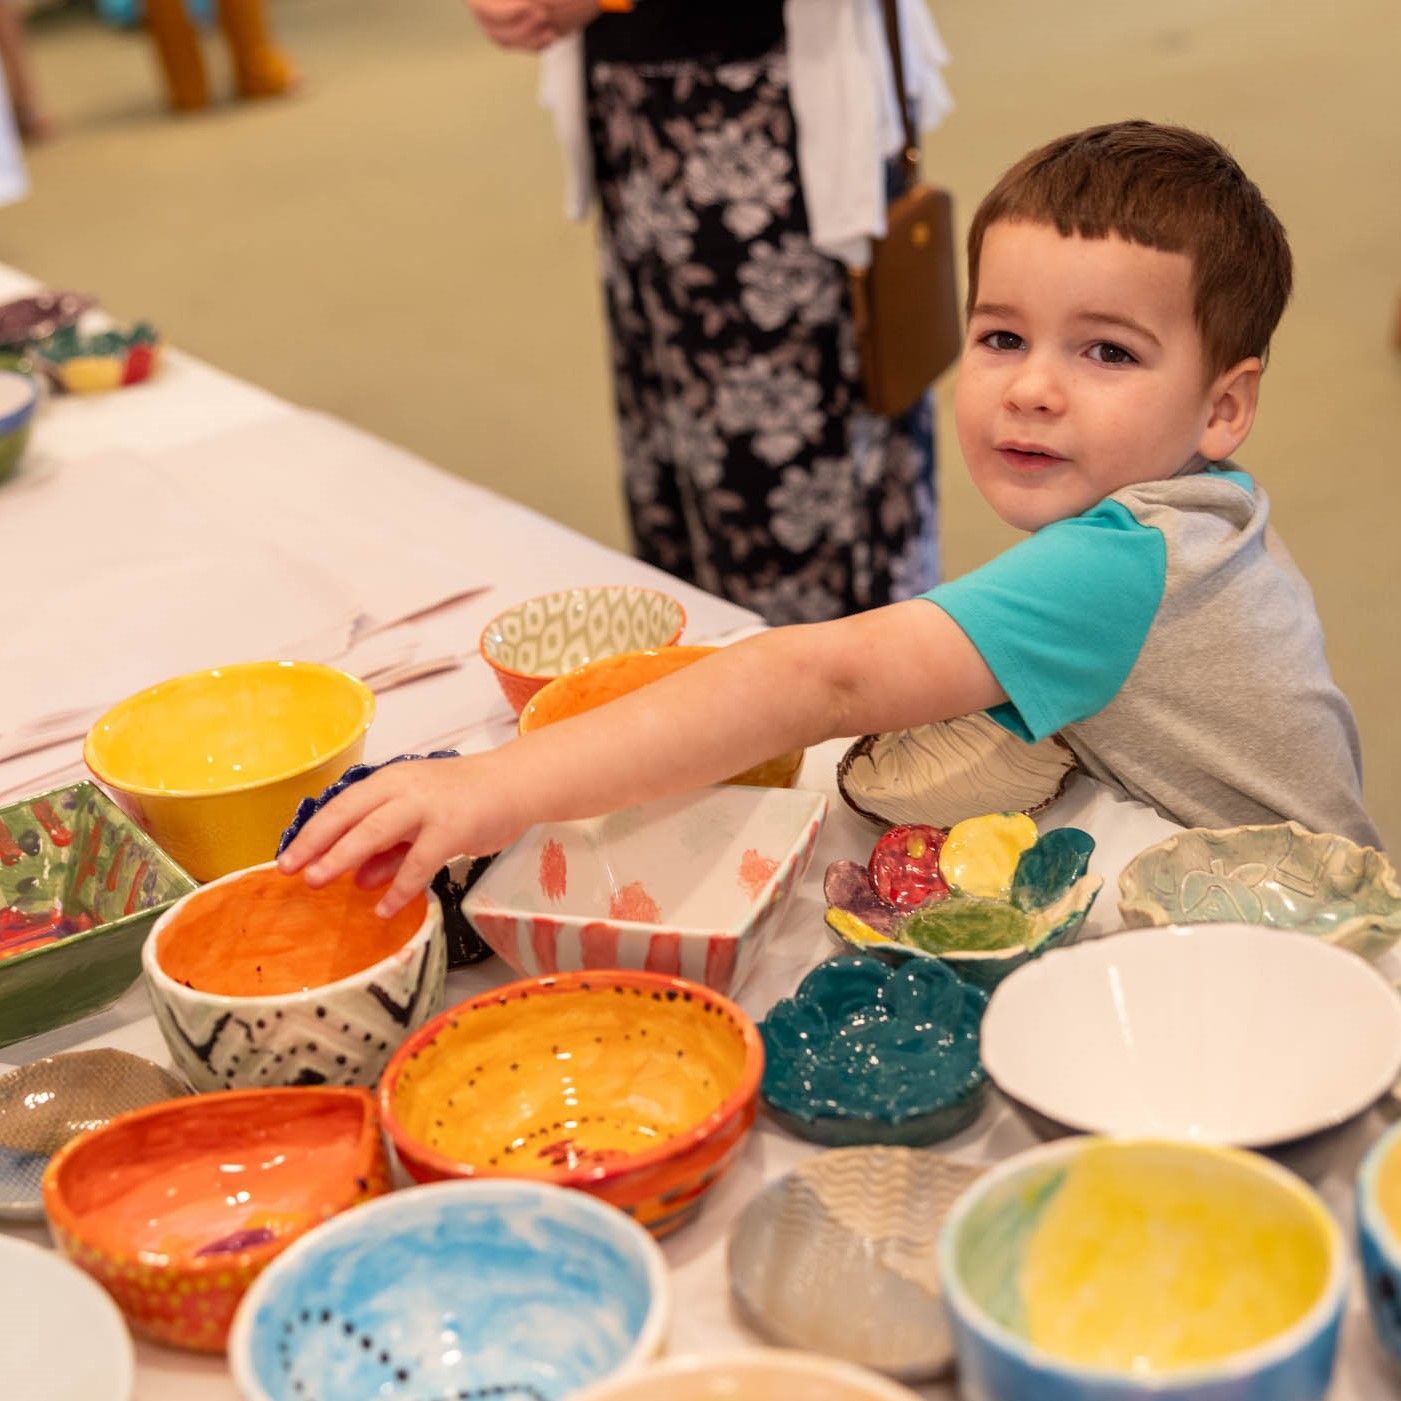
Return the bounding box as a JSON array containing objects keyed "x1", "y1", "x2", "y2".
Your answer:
[{"x1": 759, "y1": 955, "x2": 988, "y2": 1146}]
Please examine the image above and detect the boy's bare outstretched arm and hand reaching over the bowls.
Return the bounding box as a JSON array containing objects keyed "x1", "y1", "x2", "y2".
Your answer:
[{"x1": 279, "y1": 600, "x2": 1006, "y2": 915}]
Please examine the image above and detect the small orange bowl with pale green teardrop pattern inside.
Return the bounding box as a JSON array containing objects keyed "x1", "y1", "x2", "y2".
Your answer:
[{"x1": 479, "y1": 584, "x2": 686, "y2": 715}]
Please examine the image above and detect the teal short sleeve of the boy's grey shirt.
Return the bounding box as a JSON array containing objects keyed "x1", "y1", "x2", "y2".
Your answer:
[{"x1": 920, "y1": 500, "x2": 1167, "y2": 743}]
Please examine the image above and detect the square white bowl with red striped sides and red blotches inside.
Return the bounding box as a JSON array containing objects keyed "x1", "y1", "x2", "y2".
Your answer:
[{"x1": 462, "y1": 787, "x2": 827, "y2": 993}]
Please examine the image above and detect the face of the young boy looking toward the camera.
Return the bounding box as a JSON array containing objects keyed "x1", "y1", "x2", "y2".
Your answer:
[{"x1": 954, "y1": 221, "x2": 1232, "y2": 531}]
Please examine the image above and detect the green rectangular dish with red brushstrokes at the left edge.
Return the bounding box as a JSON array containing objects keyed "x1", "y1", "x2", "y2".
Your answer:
[{"x1": 0, "y1": 783, "x2": 195, "y2": 1045}]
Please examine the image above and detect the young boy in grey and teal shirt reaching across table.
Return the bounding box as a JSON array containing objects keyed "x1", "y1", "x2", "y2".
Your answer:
[{"x1": 282, "y1": 122, "x2": 1377, "y2": 915}]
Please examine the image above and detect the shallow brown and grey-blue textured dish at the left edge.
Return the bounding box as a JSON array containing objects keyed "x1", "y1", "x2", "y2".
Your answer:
[{"x1": 0, "y1": 1047, "x2": 189, "y2": 1220}]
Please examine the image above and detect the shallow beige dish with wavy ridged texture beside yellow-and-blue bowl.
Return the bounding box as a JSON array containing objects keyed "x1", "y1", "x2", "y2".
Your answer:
[{"x1": 729, "y1": 1147, "x2": 986, "y2": 1381}]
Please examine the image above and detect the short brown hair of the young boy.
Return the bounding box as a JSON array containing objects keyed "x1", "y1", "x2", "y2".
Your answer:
[{"x1": 968, "y1": 122, "x2": 1293, "y2": 375}]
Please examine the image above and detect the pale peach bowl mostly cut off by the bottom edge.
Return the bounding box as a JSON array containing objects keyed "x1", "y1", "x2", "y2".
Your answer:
[{"x1": 572, "y1": 1348, "x2": 915, "y2": 1401}]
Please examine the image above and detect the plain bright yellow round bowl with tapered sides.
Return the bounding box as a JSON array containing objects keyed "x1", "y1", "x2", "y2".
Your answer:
[{"x1": 83, "y1": 661, "x2": 374, "y2": 881}]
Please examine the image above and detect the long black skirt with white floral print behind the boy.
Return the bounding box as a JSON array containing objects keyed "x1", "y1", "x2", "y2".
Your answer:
[{"x1": 588, "y1": 52, "x2": 939, "y2": 623}]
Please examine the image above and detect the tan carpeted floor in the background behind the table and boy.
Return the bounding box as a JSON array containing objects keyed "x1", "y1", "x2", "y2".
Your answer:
[{"x1": 10, "y1": 0, "x2": 1401, "y2": 846}]
